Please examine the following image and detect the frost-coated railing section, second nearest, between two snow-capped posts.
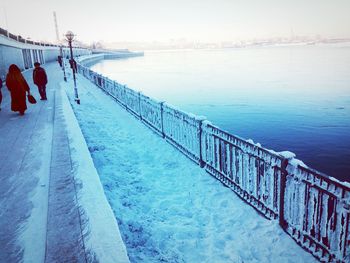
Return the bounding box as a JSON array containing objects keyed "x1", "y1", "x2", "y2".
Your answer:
[{"x1": 202, "y1": 124, "x2": 283, "y2": 219}]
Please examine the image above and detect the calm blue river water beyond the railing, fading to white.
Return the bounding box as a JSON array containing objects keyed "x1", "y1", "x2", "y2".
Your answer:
[{"x1": 92, "y1": 45, "x2": 350, "y2": 181}]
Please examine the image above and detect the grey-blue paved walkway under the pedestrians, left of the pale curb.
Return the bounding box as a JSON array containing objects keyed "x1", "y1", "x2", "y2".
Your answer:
[{"x1": 0, "y1": 63, "x2": 128, "y2": 262}]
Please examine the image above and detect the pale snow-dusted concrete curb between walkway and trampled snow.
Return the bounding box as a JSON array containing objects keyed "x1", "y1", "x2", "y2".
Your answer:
[{"x1": 58, "y1": 84, "x2": 129, "y2": 263}]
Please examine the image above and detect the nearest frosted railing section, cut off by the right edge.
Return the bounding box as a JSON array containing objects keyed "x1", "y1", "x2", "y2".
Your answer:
[{"x1": 284, "y1": 163, "x2": 350, "y2": 262}]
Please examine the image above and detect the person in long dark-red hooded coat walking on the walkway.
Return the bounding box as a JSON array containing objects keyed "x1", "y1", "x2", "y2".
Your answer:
[{"x1": 6, "y1": 64, "x2": 30, "y2": 115}]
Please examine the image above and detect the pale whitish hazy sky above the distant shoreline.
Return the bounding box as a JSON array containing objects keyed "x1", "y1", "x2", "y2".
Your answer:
[{"x1": 0, "y1": 0, "x2": 350, "y2": 43}]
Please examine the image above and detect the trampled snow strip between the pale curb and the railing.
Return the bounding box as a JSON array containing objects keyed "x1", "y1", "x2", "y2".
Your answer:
[{"x1": 64, "y1": 76, "x2": 316, "y2": 263}]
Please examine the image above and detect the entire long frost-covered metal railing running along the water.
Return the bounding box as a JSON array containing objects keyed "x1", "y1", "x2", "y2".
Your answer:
[{"x1": 78, "y1": 61, "x2": 350, "y2": 262}]
